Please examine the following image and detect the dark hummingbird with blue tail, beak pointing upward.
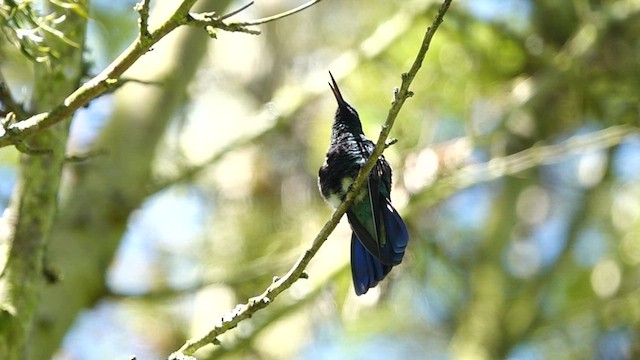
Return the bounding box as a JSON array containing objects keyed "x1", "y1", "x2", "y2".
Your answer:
[{"x1": 318, "y1": 72, "x2": 409, "y2": 295}]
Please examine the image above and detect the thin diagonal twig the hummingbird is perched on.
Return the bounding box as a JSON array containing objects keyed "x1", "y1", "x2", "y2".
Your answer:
[{"x1": 169, "y1": 0, "x2": 451, "y2": 360}]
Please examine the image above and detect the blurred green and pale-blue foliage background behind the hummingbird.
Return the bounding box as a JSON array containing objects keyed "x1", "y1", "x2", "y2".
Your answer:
[{"x1": 0, "y1": 0, "x2": 640, "y2": 359}]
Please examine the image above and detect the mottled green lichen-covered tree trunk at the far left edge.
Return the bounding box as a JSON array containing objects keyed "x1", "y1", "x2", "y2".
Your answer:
[{"x1": 0, "y1": 1, "x2": 88, "y2": 359}]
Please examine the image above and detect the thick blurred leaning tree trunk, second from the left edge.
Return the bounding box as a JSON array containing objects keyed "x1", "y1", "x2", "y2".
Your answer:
[{"x1": 29, "y1": 0, "x2": 230, "y2": 360}]
